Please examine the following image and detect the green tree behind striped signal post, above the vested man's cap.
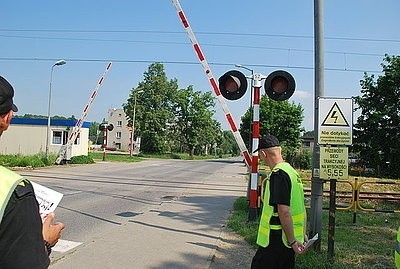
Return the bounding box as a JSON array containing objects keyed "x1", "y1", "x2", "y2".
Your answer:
[{"x1": 240, "y1": 95, "x2": 304, "y2": 163}]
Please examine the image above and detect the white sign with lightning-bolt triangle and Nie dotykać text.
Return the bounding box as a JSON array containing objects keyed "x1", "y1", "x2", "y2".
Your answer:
[{"x1": 318, "y1": 98, "x2": 353, "y2": 145}]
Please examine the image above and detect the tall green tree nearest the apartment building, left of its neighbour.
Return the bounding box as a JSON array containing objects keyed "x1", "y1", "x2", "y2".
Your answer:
[{"x1": 123, "y1": 63, "x2": 178, "y2": 153}]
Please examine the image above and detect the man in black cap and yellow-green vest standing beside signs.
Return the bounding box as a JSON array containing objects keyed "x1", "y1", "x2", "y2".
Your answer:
[{"x1": 251, "y1": 135, "x2": 307, "y2": 269}]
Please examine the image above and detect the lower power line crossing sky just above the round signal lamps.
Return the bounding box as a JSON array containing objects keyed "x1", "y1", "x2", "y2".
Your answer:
[{"x1": 0, "y1": 57, "x2": 382, "y2": 73}]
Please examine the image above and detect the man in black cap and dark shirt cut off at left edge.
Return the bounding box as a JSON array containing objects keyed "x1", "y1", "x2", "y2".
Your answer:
[{"x1": 0, "y1": 76, "x2": 65, "y2": 269}]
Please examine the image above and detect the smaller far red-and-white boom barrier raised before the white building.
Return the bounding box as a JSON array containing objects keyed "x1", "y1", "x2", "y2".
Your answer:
[{"x1": 56, "y1": 62, "x2": 112, "y2": 164}]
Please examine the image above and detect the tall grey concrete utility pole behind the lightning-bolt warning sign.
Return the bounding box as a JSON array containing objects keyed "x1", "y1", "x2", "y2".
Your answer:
[{"x1": 310, "y1": 0, "x2": 324, "y2": 251}]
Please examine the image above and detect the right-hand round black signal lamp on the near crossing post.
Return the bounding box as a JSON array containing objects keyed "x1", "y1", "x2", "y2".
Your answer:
[{"x1": 264, "y1": 70, "x2": 296, "y2": 101}]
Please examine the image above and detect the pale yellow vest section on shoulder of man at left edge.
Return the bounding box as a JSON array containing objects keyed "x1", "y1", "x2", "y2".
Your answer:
[{"x1": 0, "y1": 166, "x2": 23, "y2": 223}]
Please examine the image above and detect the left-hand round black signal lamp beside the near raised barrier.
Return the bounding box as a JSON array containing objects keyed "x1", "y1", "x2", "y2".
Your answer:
[{"x1": 218, "y1": 70, "x2": 247, "y2": 100}]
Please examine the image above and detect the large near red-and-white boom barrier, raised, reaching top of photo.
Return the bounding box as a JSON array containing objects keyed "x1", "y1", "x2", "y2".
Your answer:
[{"x1": 172, "y1": 0, "x2": 252, "y2": 167}]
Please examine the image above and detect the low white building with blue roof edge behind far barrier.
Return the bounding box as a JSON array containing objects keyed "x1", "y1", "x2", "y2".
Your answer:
[{"x1": 0, "y1": 118, "x2": 90, "y2": 156}]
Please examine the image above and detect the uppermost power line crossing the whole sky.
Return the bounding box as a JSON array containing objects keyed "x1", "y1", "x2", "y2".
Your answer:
[{"x1": 0, "y1": 29, "x2": 400, "y2": 43}]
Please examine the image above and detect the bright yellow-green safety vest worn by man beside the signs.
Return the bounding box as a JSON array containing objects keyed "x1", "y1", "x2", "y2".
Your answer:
[{"x1": 257, "y1": 162, "x2": 306, "y2": 248}]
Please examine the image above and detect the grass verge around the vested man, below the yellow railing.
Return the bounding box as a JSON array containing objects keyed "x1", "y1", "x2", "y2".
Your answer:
[{"x1": 228, "y1": 197, "x2": 400, "y2": 269}]
